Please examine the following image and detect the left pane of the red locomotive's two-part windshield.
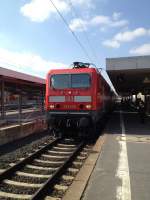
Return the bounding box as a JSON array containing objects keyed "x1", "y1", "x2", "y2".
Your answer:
[{"x1": 51, "y1": 74, "x2": 70, "y2": 89}]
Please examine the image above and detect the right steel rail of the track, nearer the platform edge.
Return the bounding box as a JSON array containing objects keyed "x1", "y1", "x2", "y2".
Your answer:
[{"x1": 31, "y1": 142, "x2": 85, "y2": 200}]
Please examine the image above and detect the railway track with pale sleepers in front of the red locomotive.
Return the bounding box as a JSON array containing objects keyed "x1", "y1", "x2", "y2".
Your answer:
[{"x1": 0, "y1": 138, "x2": 88, "y2": 200}]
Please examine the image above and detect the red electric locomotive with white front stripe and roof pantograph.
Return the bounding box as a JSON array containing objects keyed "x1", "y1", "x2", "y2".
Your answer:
[{"x1": 46, "y1": 62, "x2": 113, "y2": 138}]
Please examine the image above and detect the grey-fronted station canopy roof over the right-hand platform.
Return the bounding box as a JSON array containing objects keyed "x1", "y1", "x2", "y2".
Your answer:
[{"x1": 106, "y1": 56, "x2": 150, "y2": 96}]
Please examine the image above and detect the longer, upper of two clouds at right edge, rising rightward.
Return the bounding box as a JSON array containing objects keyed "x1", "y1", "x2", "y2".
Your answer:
[{"x1": 103, "y1": 28, "x2": 150, "y2": 48}]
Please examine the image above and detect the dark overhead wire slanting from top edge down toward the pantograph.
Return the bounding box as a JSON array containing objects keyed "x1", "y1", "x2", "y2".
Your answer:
[{"x1": 49, "y1": 0, "x2": 92, "y2": 62}]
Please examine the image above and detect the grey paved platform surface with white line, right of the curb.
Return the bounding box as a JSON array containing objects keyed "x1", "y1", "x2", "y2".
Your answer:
[{"x1": 82, "y1": 111, "x2": 150, "y2": 200}]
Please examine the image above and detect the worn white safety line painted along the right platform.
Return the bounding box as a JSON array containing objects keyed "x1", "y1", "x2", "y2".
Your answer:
[{"x1": 116, "y1": 112, "x2": 131, "y2": 200}]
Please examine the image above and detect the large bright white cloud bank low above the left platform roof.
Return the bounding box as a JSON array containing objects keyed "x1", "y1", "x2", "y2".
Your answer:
[{"x1": 0, "y1": 48, "x2": 68, "y2": 76}]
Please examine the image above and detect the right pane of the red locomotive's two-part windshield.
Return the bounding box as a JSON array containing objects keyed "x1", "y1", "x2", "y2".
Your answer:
[{"x1": 71, "y1": 74, "x2": 91, "y2": 88}]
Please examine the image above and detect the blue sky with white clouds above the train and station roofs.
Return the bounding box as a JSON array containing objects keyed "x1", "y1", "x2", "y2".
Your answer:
[{"x1": 0, "y1": 0, "x2": 150, "y2": 78}]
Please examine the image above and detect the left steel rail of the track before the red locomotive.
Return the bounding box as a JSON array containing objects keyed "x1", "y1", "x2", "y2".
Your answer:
[{"x1": 0, "y1": 138, "x2": 61, "y2": 182}]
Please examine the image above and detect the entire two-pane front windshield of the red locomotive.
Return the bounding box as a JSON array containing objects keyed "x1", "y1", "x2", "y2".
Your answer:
[{"x1": 51, "y1": 74, "x2": 91, "y2": 89}]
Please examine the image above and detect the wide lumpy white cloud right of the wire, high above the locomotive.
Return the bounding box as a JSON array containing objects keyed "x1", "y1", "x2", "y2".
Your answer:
[{"x1": 70, "y1": 13, "x2": 128, "y2": 32}]
